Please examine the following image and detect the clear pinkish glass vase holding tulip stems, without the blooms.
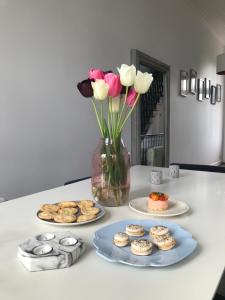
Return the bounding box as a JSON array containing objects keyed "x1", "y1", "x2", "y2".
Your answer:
[{"x1": 91, "y1": 137, "x2": 130, "y2": 206}]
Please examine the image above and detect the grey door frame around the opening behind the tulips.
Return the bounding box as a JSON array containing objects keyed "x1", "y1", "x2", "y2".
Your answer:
[{"x1": 130, "y1": 49, "x2": 170, "y2": 167}]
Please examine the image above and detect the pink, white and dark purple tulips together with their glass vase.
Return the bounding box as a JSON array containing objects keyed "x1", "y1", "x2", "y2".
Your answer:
[{"x1": 77, "y1": 64, "x2": 153, "y2": 206}]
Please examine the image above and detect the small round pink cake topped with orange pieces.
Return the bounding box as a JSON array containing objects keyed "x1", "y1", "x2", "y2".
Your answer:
[{"x1": 148, "y1": 192, "x2": 169, "y2": 211}]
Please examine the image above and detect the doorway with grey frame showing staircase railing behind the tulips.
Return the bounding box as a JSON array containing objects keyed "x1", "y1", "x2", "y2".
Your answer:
[{"x1": 131, "y1": 49, "x2": 170, "y2": 167}]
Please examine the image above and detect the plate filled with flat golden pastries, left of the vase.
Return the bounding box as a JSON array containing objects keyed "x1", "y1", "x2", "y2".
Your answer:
[{"x1": 37, "y1": 200, "x2": 105, "y2": 226}]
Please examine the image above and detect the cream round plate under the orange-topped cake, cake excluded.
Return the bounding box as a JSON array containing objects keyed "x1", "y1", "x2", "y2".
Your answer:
[{"x1": 129, "y1": 197, "x2": 189, "y2": 217}]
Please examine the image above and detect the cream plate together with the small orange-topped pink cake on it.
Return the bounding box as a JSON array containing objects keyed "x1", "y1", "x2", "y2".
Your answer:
[{"x1": 129, "y1": 192, "x2": 190, "y2": 217}]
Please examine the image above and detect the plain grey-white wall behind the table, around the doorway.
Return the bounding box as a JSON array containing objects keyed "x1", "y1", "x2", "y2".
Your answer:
[{"x1": 0, "y1": 0, "x2": 223, "y2": 198}]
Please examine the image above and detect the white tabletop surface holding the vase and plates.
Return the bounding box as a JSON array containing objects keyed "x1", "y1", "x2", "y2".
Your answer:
[{"x1": 0, "y1": 166, "x2": 225, "y2": 300}]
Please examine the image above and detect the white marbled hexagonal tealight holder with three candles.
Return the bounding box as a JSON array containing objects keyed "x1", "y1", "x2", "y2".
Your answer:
[{"x1": 17, "y1": 231, "x2": 85, "y2": 272}]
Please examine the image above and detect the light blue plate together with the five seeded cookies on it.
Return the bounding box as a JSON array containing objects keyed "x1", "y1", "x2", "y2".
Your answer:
[{"x1": 93, "y1": 220, "x2": 197, "y2": 267}]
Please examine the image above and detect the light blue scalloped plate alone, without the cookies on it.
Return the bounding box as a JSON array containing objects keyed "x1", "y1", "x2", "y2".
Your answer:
[{"x1": 93, "y1": 220, "x2": 197, "y2": 267}]
